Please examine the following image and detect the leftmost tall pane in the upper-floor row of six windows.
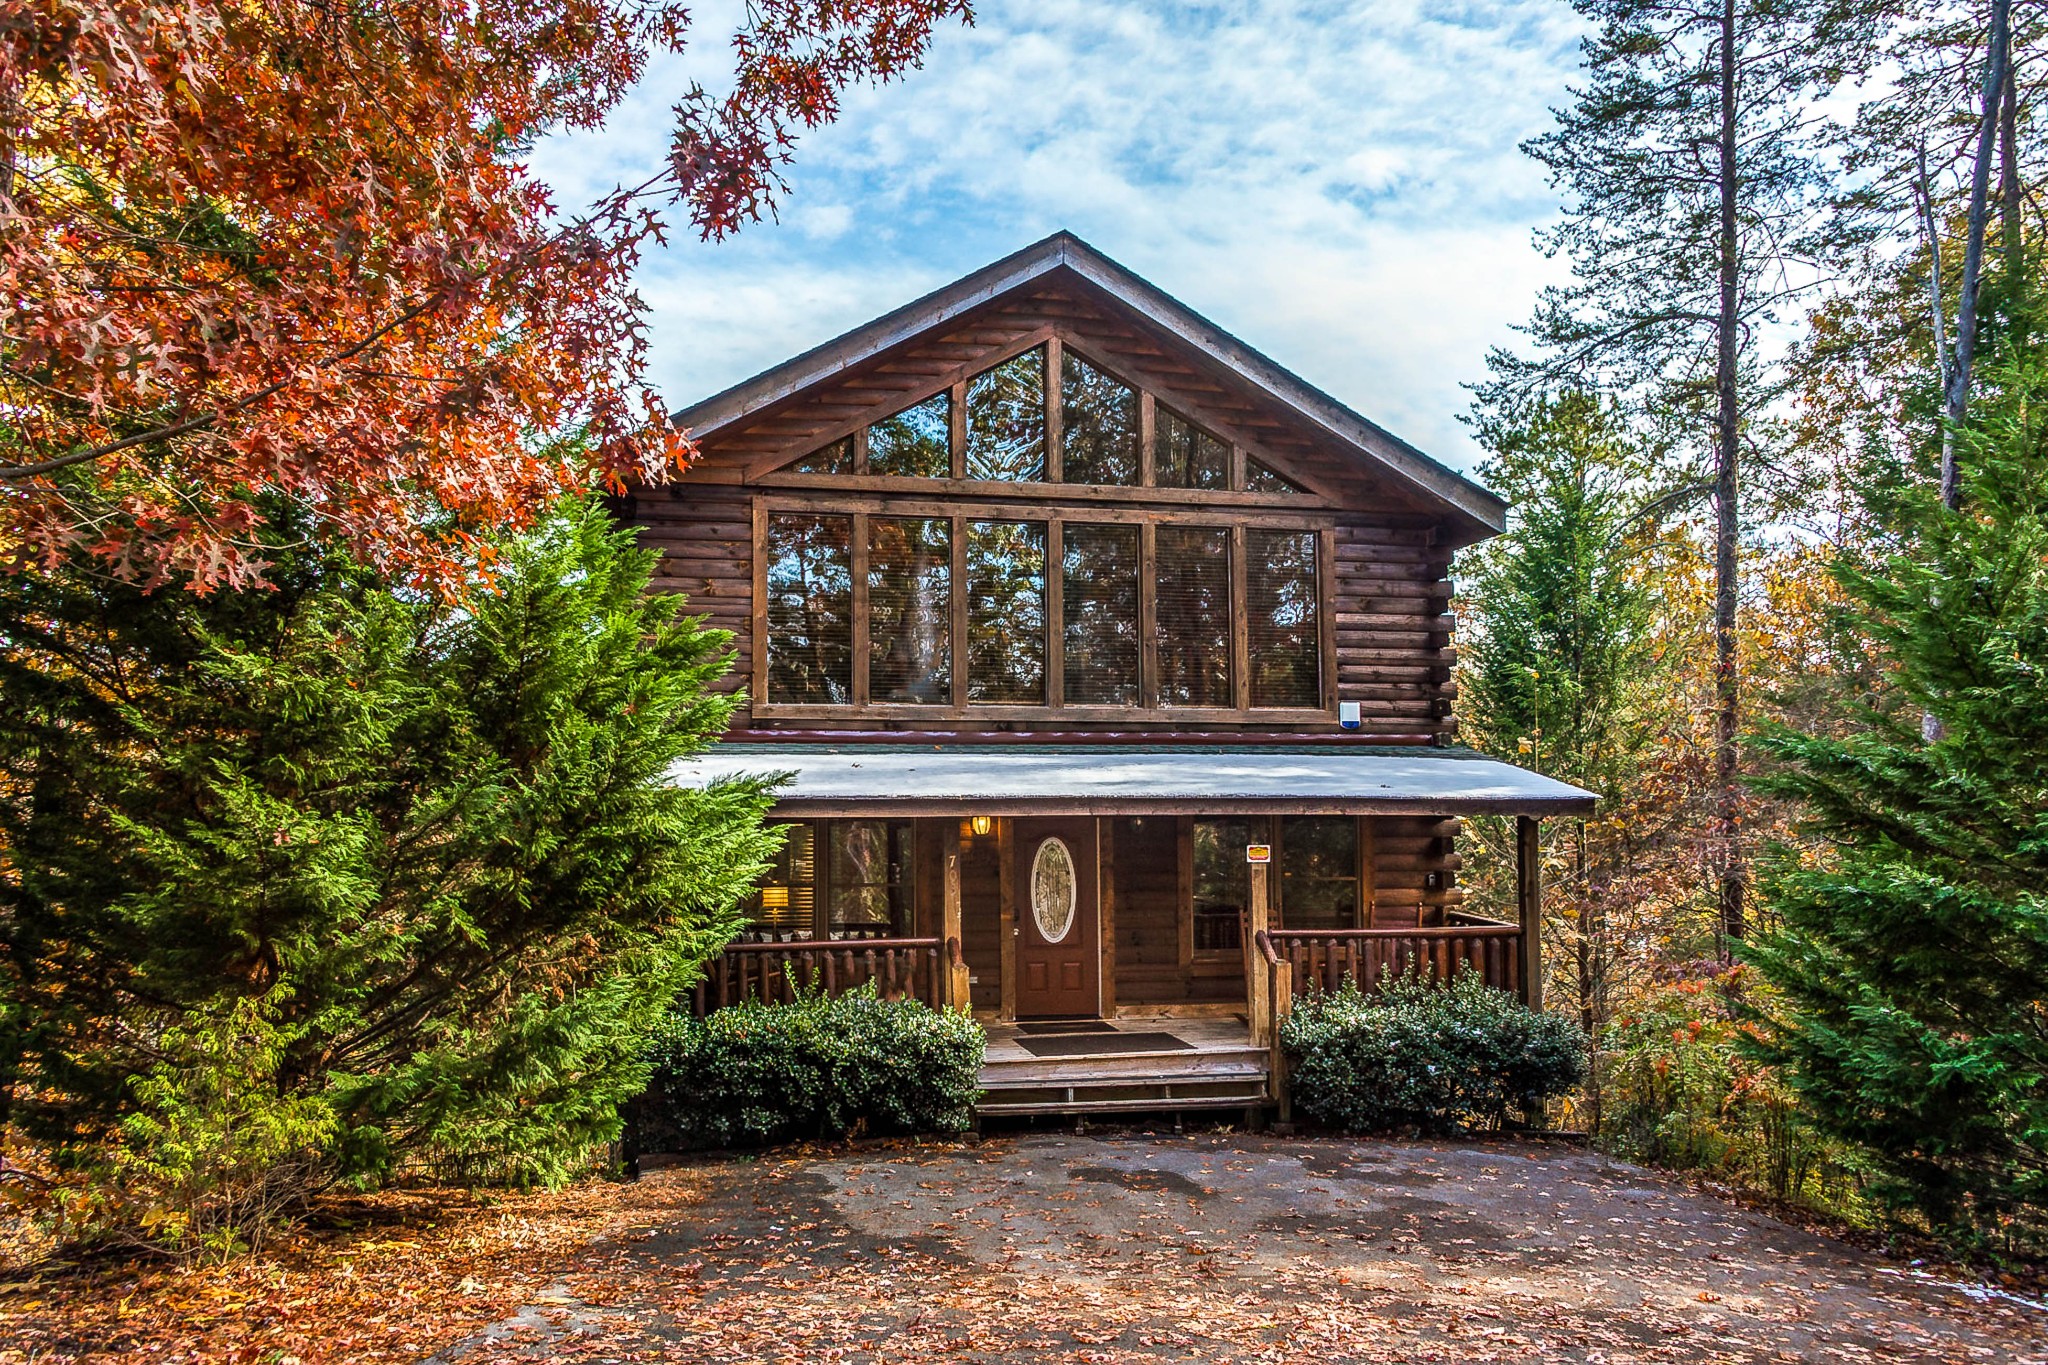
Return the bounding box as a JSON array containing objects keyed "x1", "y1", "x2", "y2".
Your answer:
[{"x1": 766, "y1": 514, "x2": 854, "y2": 706}]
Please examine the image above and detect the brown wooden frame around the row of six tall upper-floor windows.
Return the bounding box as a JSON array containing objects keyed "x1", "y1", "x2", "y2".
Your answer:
[{"x1": 752, "y1": 493, "x2": 1337, "y2": 726}]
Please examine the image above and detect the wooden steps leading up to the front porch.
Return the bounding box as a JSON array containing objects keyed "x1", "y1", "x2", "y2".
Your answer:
[{"x1": 979, "y1": 1019, "x2": 1270, "y2": 1117}]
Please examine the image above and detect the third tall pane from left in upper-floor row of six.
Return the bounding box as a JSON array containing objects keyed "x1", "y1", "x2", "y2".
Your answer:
[{"x1": 967, "y1": 522, "x2": 1044, "y2": 706}]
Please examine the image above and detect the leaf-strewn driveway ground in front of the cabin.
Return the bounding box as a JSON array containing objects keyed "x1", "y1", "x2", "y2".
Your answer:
[{"x1": 432, "y1": 1134, "x2": 2048, "y2": 1365}]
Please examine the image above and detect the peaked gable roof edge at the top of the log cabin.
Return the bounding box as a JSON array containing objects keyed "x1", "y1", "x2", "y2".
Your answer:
[{"x1": 674, "y1": 231, "x2": 1507, "y2": 542}]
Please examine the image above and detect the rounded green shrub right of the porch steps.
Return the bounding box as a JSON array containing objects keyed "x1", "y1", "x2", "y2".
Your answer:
[{"x1": 1280, "y1": 968, "x2": 1585, "y2": 1136}]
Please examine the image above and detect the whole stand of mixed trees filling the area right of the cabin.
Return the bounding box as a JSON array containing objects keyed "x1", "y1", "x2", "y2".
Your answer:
[{"x1": 1456, "y1": 0, "x2": 2048, "y2": 1254}]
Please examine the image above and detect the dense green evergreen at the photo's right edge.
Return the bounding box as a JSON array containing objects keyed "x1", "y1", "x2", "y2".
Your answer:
[{"x1": 1747, "y1": 360, "x2": 2048, "y2": 1244}]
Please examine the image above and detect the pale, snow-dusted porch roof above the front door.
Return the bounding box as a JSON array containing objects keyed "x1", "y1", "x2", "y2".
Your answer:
[{"x1": 670, "y1": 743, "x2": 1595, "y2": 817}]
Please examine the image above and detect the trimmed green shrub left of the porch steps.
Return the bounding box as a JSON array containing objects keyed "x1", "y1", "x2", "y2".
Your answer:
[{"x1": 633, "y1": 984, "x2": 983, "y2": 1150}]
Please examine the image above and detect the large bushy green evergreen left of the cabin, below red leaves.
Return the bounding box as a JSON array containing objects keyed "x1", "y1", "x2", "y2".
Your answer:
[{"x1": 0, "y1": 505, "x2": 772, "y2": 1185}]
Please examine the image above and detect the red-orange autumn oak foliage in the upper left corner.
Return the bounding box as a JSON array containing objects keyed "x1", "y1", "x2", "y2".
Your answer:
[{"x1": 0, "y1": 0, "x2": 969, "y2": 589}]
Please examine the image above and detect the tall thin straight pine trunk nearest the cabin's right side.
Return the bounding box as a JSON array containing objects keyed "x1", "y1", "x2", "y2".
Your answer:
[{"x1": 1714, "y1": 0, "x2": 1744, "y2": 939}]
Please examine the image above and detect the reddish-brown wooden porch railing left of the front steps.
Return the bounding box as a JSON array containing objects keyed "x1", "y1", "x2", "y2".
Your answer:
[{"x1": 694, "y1": 939, "x2": 965, "y2": 1015}]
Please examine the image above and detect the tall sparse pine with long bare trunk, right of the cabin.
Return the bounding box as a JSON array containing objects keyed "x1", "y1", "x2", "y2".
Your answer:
[{"x1": 1481, "y1": 0, "x2": 1872, "y2": 937}]
